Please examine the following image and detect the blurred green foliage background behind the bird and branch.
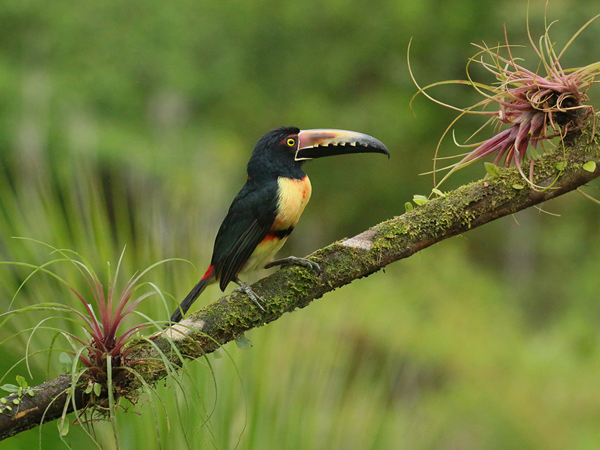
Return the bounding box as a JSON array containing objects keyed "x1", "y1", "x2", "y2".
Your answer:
[{"x1": 0, "y1": 0, "x2": 600, "y2": 450}]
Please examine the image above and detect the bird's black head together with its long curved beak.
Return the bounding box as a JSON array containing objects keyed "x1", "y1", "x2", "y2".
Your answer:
[{"x1": 248, "y1": 127, "x2": 390, "y2": 178}]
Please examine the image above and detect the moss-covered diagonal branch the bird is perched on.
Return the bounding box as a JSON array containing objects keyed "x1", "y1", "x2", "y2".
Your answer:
[{"x1": 0, "y1": 111, "x2": 600, "y2": 440}]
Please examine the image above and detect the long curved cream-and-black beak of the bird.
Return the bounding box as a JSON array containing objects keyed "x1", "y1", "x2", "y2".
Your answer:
[{"x1": 295, "y1": 129, "x2": 390, "y2": 161}]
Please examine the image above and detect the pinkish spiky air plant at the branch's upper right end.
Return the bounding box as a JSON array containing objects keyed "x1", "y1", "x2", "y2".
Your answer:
[{"x1": 409, "y1": 14, "x2": 600, "y2": 188}]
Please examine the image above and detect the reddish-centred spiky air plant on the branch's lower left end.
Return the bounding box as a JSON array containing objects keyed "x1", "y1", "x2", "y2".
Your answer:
[{"x1": 0, "y1": 239, "x2": 213, "y2": 448}]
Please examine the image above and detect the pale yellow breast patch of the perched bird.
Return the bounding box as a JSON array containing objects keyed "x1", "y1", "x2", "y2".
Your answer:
[{"x1": 272, "y1": 175, "x2": 312, "y2": 230}]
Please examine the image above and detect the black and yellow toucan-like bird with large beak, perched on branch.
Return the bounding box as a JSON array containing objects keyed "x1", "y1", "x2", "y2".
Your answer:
[{"x1": 171, "y1": 127, "x2": 390, "y2": 323}]
